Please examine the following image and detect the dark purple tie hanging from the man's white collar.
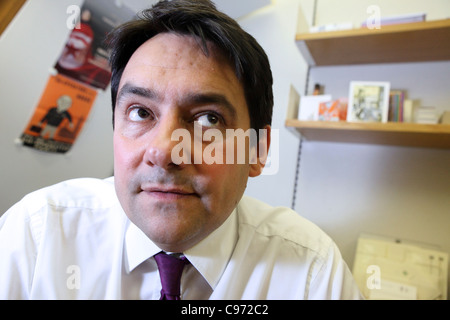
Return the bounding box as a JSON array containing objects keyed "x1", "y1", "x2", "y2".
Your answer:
[{"x1": 155, "y1": 252, "x2": 189, "y2": 300}]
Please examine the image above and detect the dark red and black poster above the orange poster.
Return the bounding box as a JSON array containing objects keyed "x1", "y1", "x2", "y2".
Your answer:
[{"x1": 55, "y1": 0, "x2": 135, "y2": 90}]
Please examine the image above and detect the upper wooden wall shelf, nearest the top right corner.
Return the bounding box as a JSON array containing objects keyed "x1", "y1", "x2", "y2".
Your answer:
[{"x1": 296, "y1": 19, "x2": 450, "y2": 66}]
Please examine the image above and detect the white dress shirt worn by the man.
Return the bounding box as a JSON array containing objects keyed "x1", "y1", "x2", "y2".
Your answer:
[{"x1": 0, "y1": 178, "x2": 362, "y2": 300}]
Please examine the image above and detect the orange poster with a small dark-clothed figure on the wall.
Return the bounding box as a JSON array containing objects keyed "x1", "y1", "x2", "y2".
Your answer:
[{"x1": 21, "y1": 75, "x2": 97, "y2": 153}]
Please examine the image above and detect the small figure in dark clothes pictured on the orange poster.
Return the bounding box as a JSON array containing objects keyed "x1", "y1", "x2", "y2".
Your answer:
[{"x1": 38, "y1": 95, "x2": 74, "y2": 139}]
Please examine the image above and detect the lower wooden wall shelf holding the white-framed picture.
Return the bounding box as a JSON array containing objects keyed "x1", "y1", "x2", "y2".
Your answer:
[{"x1": 286, "y1": 119, "x2": 450, "y2": 149}]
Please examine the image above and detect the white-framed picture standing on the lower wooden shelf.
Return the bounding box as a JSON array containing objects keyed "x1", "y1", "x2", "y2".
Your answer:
[{"x1": 347, "y1": 81, "x2": 391, "y2": 122}]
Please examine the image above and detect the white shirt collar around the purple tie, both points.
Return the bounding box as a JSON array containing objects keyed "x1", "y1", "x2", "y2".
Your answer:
[{"x1": 125, "y1": 209, "x2": 238, "y2": 290}]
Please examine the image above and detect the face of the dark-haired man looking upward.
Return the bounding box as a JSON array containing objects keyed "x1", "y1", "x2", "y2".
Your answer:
[{"x1": 114, "y1": 33, "x2": 263, "y2": 252}]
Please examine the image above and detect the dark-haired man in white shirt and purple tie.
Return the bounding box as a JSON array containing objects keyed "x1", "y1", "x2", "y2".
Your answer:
[{"x1": 0, "y1": 0, "x2": 360, "y2": 299}]
